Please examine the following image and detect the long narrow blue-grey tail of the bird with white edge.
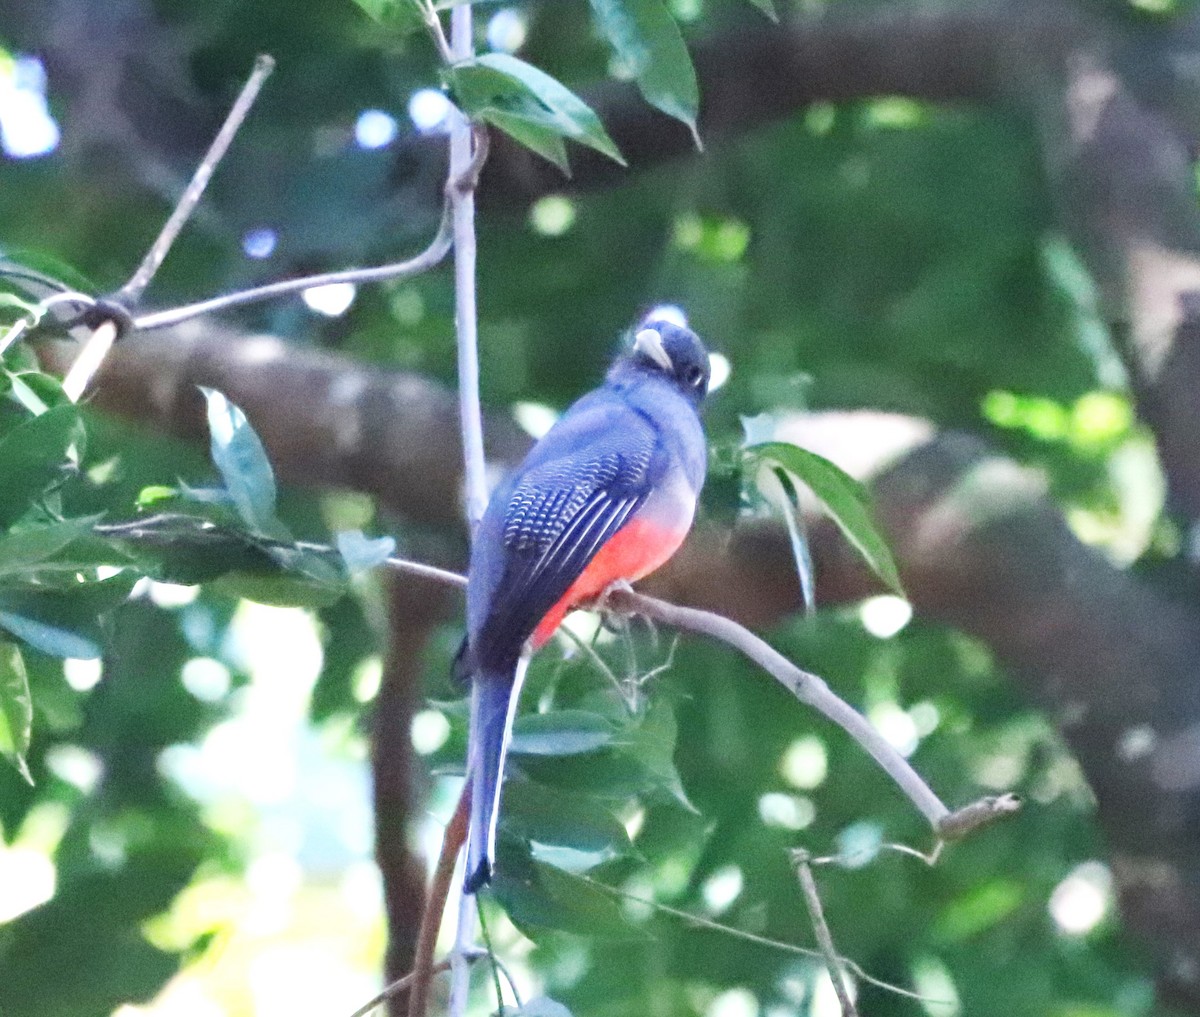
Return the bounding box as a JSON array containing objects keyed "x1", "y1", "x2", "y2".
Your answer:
[{"x1": 463, "y1": 656, "x2": 529, "y2": 893}]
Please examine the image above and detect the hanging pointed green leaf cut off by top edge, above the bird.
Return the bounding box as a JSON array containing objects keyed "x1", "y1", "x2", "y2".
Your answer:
[{"x1": 592, "y1": 0, "x2": 700, "y2": 148}]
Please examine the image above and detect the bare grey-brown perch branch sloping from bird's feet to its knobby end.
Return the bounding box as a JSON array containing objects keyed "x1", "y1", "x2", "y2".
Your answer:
[{"x1": 602, "y1": 586, "x2": 950, "y2": 832}]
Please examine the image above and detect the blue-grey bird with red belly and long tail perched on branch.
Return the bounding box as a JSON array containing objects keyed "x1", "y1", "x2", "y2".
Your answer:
[{"x1": 456, "y1": 317, "x2": 710, "y2": 893}]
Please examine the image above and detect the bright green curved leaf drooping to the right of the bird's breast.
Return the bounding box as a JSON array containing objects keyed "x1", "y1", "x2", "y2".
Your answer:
[{"x1": 745, "y1": 441, "x2": 905, "y2": 597}]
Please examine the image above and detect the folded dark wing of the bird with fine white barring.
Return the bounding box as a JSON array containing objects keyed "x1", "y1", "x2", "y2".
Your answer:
[{"x1": 474, "y1": 414, "x2": 656, "y2": 660}]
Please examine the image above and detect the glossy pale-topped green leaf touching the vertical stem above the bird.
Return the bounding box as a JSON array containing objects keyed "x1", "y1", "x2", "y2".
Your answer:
[{"x1": 450, "y1": 53, "x2": 625, "y2": 166}]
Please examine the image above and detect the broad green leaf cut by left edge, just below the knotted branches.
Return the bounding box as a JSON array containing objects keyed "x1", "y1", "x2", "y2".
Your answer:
[{"x1": 0, "y1": 405, "x2": 84, "y2": 526}]
